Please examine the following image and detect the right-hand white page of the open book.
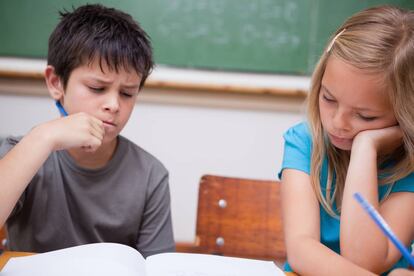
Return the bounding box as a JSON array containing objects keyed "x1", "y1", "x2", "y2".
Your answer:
[{"x1": 147, "y1": 253, "x2": 285, "y2": 276}]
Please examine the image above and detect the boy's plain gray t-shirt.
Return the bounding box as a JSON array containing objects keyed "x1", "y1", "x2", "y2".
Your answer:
[{"x1": 0, "y1": 136, "x2": 175, "y2": 257}]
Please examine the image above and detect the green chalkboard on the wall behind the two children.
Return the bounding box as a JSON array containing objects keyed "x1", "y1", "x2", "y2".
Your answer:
[{"x1": 0, "y1": 0, "x2": 414, "y2": 74}]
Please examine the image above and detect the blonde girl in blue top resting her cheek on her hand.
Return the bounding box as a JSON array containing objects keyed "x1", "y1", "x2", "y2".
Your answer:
[{"x1": 280, "y1": 6, "x2": 414, "y2": 275}]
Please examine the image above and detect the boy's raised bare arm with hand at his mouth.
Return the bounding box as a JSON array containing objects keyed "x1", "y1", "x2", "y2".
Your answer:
[{"x1": 0, "y1": 113, "x2": 103, "y2": 226}]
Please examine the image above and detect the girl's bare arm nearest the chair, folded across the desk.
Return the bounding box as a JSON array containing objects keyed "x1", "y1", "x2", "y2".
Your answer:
[{"x1": 281, "y1": 169, "x2": 374, "y2": 275}]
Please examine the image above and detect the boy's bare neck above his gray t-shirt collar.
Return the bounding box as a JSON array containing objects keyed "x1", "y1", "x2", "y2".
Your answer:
[{"x1": 67, "y1": 138, "x2": 118, "y2": 169}]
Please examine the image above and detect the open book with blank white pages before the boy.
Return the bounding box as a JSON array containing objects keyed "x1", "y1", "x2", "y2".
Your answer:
[{"x1": 0, "y1": 243, "x2": 284, "y2": 276}]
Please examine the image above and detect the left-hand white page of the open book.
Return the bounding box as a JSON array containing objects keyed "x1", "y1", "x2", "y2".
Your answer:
[{"x1": 0, "y1": 243, "x2": 146, "y2": 276}]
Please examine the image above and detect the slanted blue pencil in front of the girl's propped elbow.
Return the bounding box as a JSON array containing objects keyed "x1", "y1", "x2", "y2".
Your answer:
[{"x1": 354, "y1": 193, "x2": 414, "y2": 266}]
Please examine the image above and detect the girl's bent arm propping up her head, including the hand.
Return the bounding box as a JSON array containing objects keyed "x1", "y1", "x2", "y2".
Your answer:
[{"x1": 340, "y1": 127, "x2": 414, "y2": 273}]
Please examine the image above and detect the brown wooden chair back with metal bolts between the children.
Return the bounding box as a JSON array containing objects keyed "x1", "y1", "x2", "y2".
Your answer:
[{"x1": 177, "y1": 175, "x2": 286, "y2": 264}]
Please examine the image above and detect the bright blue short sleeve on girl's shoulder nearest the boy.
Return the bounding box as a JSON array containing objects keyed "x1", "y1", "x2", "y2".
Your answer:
[{"x1": 278, "y1": 122, "x2": 312, "y2": 179}]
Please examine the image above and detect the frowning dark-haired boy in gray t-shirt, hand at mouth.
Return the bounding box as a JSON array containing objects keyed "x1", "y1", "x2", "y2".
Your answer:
[{"x1": 0, "y1": 5, "x2": 174, "y2": 256}]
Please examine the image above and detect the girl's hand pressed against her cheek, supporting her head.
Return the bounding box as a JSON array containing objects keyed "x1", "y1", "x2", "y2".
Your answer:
[{"x1": 352, "y1": 125, "x2": 403, "y2": 155}]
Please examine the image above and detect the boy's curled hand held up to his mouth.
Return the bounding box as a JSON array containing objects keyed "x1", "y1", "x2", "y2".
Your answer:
[{"x1": 34, "y1": 112, "x2": 105, "y2": 152}]
